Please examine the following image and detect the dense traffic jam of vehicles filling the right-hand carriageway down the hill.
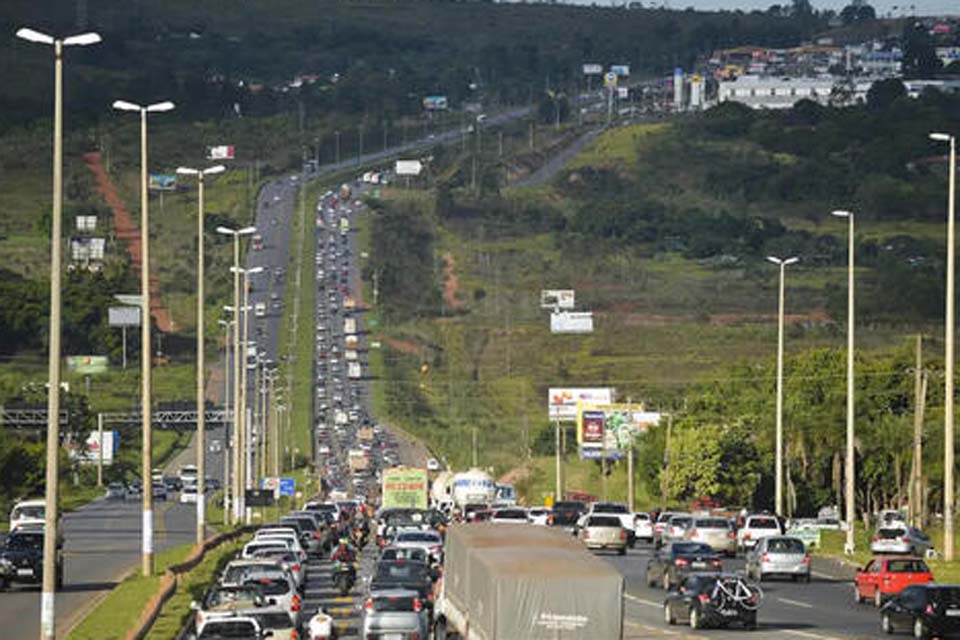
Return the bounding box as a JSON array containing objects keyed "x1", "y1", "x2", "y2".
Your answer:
[{"x1": 178, "y1": 176, "x2": 960, "y2": 640}]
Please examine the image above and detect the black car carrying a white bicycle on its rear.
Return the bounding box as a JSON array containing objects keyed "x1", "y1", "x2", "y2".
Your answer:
[{"x1": 663, "y1": 573, "x2": 763, "y2": 631}]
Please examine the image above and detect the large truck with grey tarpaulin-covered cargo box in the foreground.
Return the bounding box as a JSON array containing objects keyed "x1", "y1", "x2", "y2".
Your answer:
[{"x1": 434, "y1": 523, "x2": 624, "y2": 640}]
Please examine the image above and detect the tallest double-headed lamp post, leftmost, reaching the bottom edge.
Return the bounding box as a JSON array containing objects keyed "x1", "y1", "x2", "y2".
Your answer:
[{"x1": 17, "y1": 27, "x2": 100, "y2": 640}]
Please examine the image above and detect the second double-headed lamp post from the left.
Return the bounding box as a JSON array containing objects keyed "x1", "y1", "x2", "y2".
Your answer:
[{"x1": 113, "y1": 100, "x2": 174, "y2": 576}]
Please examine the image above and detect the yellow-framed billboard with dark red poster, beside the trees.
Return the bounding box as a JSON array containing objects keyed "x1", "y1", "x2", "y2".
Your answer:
[{"x1": 577, "y1": 402, "x2": 660, "y2": 459}]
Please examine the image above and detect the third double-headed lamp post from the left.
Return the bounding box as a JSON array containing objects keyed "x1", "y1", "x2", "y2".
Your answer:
[{"x1": 177, "y1": 164, "x2": 226, "y2": 544}]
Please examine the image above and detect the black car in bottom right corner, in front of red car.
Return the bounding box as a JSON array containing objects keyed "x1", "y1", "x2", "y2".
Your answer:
[{"x1": 880, "y1": 583, "x2": 960, "y2": 638}]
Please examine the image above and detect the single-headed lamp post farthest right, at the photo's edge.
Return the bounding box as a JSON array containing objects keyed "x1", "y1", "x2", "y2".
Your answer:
[{"x1": 930, "y1": 133, "x2": 957, "y2": 562}]
